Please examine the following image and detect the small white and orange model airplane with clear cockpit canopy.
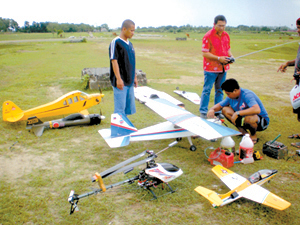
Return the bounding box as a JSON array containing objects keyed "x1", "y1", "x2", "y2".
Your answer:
[{"x1": 195, "y1": 165, "x2": 291, "y2": 210}]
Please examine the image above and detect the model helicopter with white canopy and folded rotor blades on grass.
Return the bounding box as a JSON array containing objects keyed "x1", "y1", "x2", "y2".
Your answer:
[{"x1": 68, "y1": 142, "x2": 183, "y2": 214}]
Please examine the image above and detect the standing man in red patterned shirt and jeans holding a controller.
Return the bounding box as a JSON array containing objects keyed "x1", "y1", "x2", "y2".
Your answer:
[{"x1": 199, "y1": 15, "x2": 234, "y2": 118}]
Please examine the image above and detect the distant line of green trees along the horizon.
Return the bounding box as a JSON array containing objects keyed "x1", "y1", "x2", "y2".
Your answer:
[{"x1": 0, "y1": 17, "x2": 290, "y2": 34}]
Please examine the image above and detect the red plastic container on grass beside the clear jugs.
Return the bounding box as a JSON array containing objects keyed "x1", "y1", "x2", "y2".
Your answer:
[{"x1": 208, "y1": 148, "x2": 234, "y2": 168}]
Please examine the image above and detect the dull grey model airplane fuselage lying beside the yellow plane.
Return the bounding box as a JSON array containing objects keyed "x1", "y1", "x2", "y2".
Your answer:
[{"x1": 26, "y1": 113, "x2": 105, "y2": 137}]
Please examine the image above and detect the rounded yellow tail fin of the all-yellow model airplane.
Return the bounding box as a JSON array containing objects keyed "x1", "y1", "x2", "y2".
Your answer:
[{"x1": 2, "y1": 101, "x2": 24, "y2": 122}]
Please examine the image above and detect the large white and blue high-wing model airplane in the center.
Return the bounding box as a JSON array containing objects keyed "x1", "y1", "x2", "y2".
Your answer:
[{"x1": 98, "y1": 98, "x2": 240, "y2": 151}]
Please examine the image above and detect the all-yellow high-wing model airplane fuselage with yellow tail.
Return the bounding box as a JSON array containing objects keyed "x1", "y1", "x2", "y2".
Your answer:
[{"x1": 2, "y1": 91, "x2": 104, "y2": 122}]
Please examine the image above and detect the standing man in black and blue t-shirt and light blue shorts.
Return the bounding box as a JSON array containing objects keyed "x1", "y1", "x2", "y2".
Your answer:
[{"x1": 109, "y1": 20, "x2": 137, "y2": 115}]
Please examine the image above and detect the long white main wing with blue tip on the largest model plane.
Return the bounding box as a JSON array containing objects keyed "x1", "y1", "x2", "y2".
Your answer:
[{"x1": 145, "y1": 99, "x2": 240, "y2": 140}]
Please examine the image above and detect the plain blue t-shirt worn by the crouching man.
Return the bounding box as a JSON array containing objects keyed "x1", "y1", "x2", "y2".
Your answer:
[{"x1": 220, "y1": 88, "x2": 270, "y2": 123}]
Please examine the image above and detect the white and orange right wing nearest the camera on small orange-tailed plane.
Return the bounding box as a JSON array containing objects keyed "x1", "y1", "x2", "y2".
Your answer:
[{"x1": 238, "y1": 184, "x2": 291, "y2": 210}]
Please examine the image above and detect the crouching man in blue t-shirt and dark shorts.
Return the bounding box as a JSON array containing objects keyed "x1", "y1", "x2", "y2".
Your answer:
[{"x1": 207, "y1": 79, "x2": 270, "y2": 144}]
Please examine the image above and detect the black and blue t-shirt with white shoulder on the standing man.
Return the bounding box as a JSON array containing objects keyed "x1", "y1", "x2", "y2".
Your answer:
[{"x1": 109, "y1": 37, "x2": 135, "y2": 87}]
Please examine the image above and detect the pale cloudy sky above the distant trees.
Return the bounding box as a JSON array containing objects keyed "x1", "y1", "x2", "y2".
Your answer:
[{"x1": 0, "y1": 0, "x2": 300, "y2": 29}]
